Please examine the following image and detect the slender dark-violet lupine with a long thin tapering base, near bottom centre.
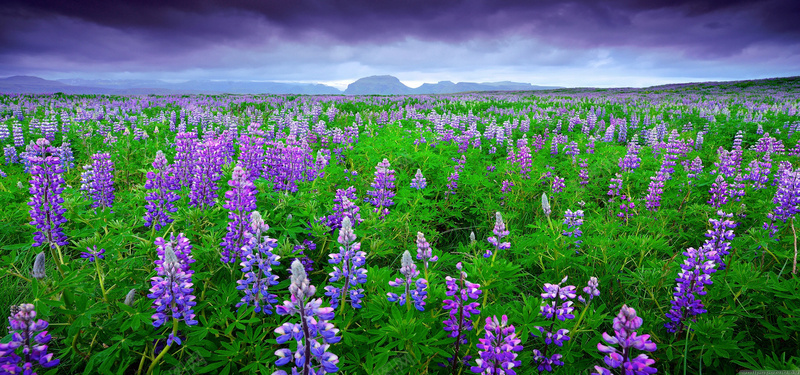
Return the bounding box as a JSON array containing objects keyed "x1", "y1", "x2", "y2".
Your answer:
[{"x1": 442, "y1": 262, "x2": 481, "y2": 374}]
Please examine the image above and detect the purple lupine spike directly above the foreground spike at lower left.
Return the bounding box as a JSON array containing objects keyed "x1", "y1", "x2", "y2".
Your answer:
[{"x1": 144, "y1": 150, "x2": 181, "y2": 231}]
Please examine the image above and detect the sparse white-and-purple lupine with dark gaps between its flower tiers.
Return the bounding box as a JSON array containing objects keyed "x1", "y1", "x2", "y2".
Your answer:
[{"x1": 531, "y1": 276, "x2": 576, "y2": 372}]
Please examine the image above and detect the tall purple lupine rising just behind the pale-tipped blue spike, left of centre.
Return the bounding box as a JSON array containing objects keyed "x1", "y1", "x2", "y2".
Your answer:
[{"x1": 220, "y1": 165, "x2": 258, "y2": 263}]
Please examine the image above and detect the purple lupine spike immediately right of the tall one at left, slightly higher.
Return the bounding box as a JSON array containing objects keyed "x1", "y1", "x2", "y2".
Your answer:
[{"x1": 189, "y1": 139, "x2": 224, "y2": 208}]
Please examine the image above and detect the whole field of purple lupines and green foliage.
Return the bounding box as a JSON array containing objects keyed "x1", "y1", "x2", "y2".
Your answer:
[{"x1": 0, "y1": 79, "x2": 800, "y2": 375}]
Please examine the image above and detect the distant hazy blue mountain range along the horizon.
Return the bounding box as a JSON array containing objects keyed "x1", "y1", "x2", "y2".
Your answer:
[{"x1": 0, "y1": 76, "x2": 559, "y2": 95}]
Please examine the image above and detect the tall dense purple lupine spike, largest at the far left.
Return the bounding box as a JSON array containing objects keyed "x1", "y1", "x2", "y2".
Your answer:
[{"x1": 27, "y1": 138, "x2": 67, "y2": 247}]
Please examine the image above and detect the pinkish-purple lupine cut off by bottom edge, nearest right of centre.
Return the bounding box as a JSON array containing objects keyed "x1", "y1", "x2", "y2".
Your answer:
[{"x1": 470, "y1": 315, "x2": 523, "y2": 375}]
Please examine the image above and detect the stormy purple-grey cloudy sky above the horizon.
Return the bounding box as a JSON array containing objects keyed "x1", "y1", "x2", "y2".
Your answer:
[{"x1": 0, "y1": 0, "x2": 800, "y2": 88}]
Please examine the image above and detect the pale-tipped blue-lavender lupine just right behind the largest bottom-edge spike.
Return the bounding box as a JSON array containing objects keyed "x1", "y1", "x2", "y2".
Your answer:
[{"x1": 325, "y1": 217, "x2": 367, "y2": 309}]
